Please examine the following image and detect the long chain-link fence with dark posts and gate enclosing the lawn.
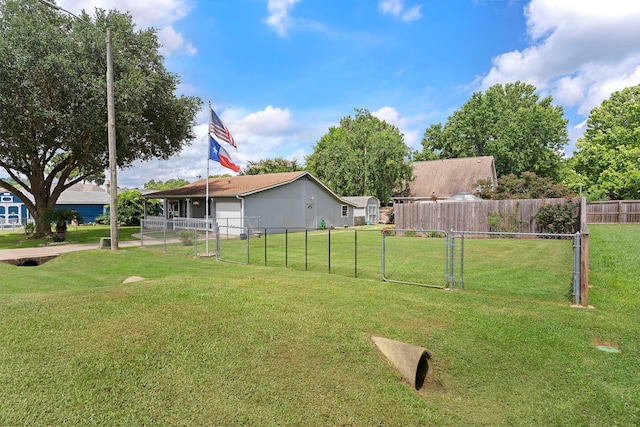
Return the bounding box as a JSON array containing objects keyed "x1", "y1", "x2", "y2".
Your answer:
[{"x1": 141, "y1": 220, "x2": 581, "y2": 303}]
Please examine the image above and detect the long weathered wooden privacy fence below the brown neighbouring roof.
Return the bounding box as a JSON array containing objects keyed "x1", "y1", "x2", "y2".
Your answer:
[{"x1": 394, "y1": 198, "x2": 581, "y2": 233}]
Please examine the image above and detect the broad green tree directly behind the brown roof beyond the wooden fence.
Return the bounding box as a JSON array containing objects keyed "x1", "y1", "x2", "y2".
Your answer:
[{"x1": 415, "y1": 82, "x2": 568, "y2": 179}]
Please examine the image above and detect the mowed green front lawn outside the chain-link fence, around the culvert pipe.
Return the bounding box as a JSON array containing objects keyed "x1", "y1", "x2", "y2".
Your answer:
[{"x1": 0, "y1": 226, "x2": 640, "y2": 426}]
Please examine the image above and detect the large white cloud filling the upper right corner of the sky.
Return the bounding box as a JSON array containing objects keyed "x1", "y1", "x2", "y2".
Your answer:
[{"x1": 481, "y1": 0, "x2": 640, "y2": 116}]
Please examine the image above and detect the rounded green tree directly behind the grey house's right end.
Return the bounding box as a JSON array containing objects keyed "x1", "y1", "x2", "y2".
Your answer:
[{"x1": 305, "y1": 109, "x2": 413, "y2": 203}]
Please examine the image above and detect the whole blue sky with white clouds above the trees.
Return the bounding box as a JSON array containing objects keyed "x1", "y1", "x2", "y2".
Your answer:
[{"x1": 57, "y1": 0, "x2": 640, "y2": 188}]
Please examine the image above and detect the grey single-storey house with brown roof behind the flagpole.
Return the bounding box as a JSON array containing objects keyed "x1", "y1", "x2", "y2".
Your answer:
[{"x1": 143, "y1": 171, "x2": 354, "y2": 234}]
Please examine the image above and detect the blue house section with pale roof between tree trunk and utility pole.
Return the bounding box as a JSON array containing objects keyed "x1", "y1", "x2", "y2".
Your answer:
[{"x1": 56, "y1": 183, "x2": 109, "y2": 223}]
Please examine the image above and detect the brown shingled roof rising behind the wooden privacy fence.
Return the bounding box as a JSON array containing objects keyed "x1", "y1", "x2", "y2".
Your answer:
[{"x1": 393, "y1": 156, "x2": 498, "y2": 203}]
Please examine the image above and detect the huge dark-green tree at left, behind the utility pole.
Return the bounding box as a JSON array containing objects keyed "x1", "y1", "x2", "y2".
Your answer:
[{"x1": 0, "y1": 0, "x2": 201, "y2": 234}]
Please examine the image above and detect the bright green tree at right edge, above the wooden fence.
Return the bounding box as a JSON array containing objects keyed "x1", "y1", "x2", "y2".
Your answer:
[{"x1": 566, "y1": 85, "x2": 640, "y2": 200}]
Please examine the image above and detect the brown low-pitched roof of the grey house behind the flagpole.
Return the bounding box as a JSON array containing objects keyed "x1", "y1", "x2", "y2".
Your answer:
[{"x1": 142, "y1": 171, "x2": 352, "y2": 204}]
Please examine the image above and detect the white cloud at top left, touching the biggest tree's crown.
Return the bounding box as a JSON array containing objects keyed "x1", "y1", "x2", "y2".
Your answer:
[{"x1": 58, "y1": 0, "x2": 196, "y2": 55}]
